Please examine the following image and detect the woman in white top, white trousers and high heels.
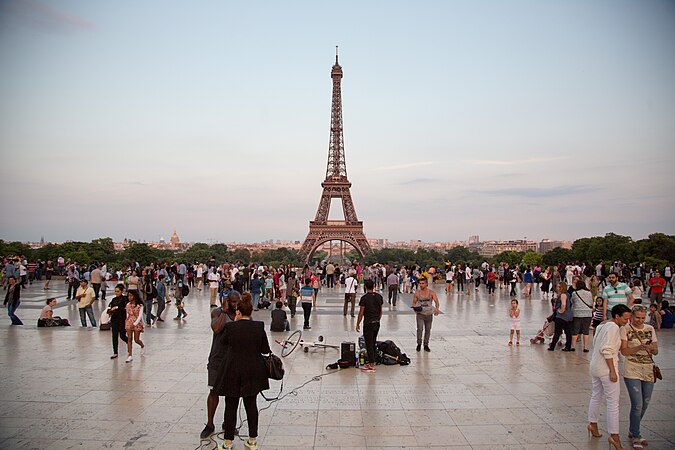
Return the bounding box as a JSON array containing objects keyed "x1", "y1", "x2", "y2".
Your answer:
[{"x1": 586, "y1": 304, "x2": 631, "y2": 450}]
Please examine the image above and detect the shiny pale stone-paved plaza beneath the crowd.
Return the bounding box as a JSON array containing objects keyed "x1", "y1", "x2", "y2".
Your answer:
[{"x1": 0, "y1": 281, "x2": 675, "y2": 450}]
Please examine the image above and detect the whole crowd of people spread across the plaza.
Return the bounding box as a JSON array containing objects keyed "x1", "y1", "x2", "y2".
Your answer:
[{"x1": 3, "y1": 258, "x2": 674, "y2": 449}]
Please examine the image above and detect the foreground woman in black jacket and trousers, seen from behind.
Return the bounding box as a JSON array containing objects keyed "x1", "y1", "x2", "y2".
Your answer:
[{"x1": 213, "y1": 292, "x2": 271, "y2": 449}]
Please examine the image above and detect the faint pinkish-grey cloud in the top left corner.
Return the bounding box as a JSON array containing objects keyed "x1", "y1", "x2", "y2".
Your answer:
[{"x1": 0, "y1": 0, "x2": 96, "y2": 33}]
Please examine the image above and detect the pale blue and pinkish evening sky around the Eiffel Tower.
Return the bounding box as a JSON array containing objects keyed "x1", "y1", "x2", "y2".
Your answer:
[{"x1": 0, "y1": 0, "x2": 675, "y2": 246}]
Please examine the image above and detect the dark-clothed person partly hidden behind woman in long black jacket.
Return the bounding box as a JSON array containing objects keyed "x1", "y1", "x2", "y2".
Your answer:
[{"x1": 199, "y1": 291, "x2": 241, "y2": 439}]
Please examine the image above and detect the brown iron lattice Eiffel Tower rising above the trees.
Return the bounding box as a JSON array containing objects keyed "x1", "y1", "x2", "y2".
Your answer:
[{"x1": 300, "y1": 47, "x2": 372, "y2": 262}]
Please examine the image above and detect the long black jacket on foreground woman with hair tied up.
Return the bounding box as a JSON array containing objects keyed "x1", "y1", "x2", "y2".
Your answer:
[{"x1": 213, "y1": 320, "x2": 271, "y2": 397}]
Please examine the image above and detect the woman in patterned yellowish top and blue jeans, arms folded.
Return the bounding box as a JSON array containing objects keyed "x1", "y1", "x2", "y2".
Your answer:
[{"x1": 620, "y1": 305, "x2": 659, "y2": 449}]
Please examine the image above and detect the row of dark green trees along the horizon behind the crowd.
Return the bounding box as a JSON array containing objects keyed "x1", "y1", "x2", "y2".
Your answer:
[{"x1": 0, "y1": 233, "x2": 675, "y2": 267}]
